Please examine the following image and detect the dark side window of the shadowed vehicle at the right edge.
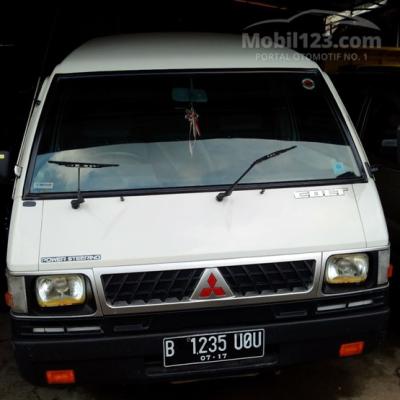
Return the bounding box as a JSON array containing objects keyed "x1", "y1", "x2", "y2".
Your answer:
[{"x1": 363, "y1": 92, "x2": 400, "y2": 169}]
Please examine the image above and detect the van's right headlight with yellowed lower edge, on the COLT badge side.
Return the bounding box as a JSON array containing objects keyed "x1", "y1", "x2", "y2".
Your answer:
[{"x1": 325, "y1": 254, "x2": 369, "y2": 285}]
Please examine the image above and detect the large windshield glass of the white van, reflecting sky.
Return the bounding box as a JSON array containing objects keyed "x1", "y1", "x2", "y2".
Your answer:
[{"x1": 29, "y1": 71, "x2": 360, "y2": 194}]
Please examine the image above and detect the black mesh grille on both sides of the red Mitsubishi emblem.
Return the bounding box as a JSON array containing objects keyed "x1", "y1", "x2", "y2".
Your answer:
[{"x1": 101, "y1": 260, "x2": 316, "y2": 307}]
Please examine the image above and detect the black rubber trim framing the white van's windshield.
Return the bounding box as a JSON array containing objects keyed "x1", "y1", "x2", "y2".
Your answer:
[{"x1": 23, "y1": 68, "x2": 368, "y2": 200}]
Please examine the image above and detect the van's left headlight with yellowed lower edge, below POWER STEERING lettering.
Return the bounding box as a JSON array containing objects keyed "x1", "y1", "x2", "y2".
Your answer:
[{"x1": 36, "y1": 275, "x2": 86, "y2": 307}]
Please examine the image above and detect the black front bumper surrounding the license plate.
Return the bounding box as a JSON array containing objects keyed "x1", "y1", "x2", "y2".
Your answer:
[{"x1": 13, "y1": 291, "x2": 389, "y2": 384}]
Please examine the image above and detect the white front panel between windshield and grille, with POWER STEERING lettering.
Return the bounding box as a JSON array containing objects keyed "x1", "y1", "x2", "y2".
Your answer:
[{"x1": 34, "y1": 185, "x2": 366, "y2": 270}]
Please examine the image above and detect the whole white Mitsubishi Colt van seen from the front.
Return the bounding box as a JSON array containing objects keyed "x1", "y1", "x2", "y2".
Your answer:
[{"x1": 2, "y1": 34, "x2": 389, "y2": 384}]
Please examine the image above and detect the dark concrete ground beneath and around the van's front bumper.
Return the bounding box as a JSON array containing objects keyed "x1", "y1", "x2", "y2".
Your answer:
[{"x1": 0, "y1": 314, "x2": 400, "y2": 400}]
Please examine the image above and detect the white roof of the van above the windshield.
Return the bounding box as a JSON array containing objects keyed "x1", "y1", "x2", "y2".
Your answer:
[{"x1": 54, "y1": 33, "x2": 318, "y2": 74}]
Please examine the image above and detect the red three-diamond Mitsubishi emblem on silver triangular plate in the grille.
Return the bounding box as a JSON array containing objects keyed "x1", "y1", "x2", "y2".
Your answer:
[{"x1": 191, "y1": 268, "x2": 233, "y2": 300}]
